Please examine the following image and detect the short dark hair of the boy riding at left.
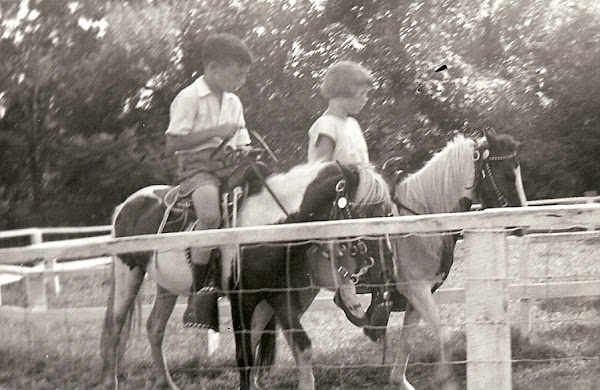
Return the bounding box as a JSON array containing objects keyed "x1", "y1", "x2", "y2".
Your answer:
[{"x1": 202, "y1": 33, "x2": 253, "y2": 66}]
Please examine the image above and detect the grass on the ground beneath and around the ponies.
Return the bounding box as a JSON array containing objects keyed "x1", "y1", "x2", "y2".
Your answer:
[{"x1": 0, "y1": 239, "x2": 600, "y2": 390}]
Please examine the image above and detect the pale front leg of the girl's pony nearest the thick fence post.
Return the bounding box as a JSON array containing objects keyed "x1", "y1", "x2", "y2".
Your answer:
[{"x1": 398, "y1": 281, "x2": 457, "y2": 390}]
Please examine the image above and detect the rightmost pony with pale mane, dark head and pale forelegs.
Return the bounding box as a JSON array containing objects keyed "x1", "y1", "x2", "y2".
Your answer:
[{"x1": 390, "y1": 131, "x2": 527, "y2": 390}]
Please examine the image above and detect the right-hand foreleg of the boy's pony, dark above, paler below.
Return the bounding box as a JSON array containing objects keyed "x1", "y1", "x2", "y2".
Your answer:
[{"x1": 269, "y1": 293, "x2": 315, "y2": 390}]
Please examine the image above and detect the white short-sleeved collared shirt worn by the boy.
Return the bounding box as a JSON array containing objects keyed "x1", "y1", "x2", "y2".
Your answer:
[{"x1": 166, "y1": 76, "x2": 250, "y2": 154}]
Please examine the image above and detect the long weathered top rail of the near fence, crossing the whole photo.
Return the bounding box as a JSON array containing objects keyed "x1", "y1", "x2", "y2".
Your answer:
[{"x1": 0, "y1": 204, "x2": 600, "y2": 264}]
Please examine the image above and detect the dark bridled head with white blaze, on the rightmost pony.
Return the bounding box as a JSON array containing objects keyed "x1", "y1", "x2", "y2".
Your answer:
[{"x1": 473, "y1": 130, "x2": 527, "y2": 208}]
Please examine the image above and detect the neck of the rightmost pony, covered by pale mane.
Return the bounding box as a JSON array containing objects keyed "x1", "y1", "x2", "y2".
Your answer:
[{"x1": 395, "y1": 135, "x2": 475, "y2": 214}]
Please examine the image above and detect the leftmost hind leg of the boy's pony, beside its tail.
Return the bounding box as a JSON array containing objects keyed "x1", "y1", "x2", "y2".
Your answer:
[{"x1": 100, "y1": 256, "x2": 145, "y2": 389}]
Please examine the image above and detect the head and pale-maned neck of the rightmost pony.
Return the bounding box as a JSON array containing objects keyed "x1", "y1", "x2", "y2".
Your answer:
[{"x1": 394, "y1": 131, "x2": 526, "y2": 214}]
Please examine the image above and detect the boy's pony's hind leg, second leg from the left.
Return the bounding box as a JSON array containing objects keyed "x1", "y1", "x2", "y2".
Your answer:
[{"x1": 146, "y1": 285, "x2": 179, "y2": 390}]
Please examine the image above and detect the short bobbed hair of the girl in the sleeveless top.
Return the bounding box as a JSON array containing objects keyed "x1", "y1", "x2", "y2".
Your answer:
[{"x1": 321, "y1": 61, "x2": 373, "y2": 99}]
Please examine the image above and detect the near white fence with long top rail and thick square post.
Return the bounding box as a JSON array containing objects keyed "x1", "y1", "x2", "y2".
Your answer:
[{"x1": 0, "y1": 204, "x2": 600, "y2": 390}]
